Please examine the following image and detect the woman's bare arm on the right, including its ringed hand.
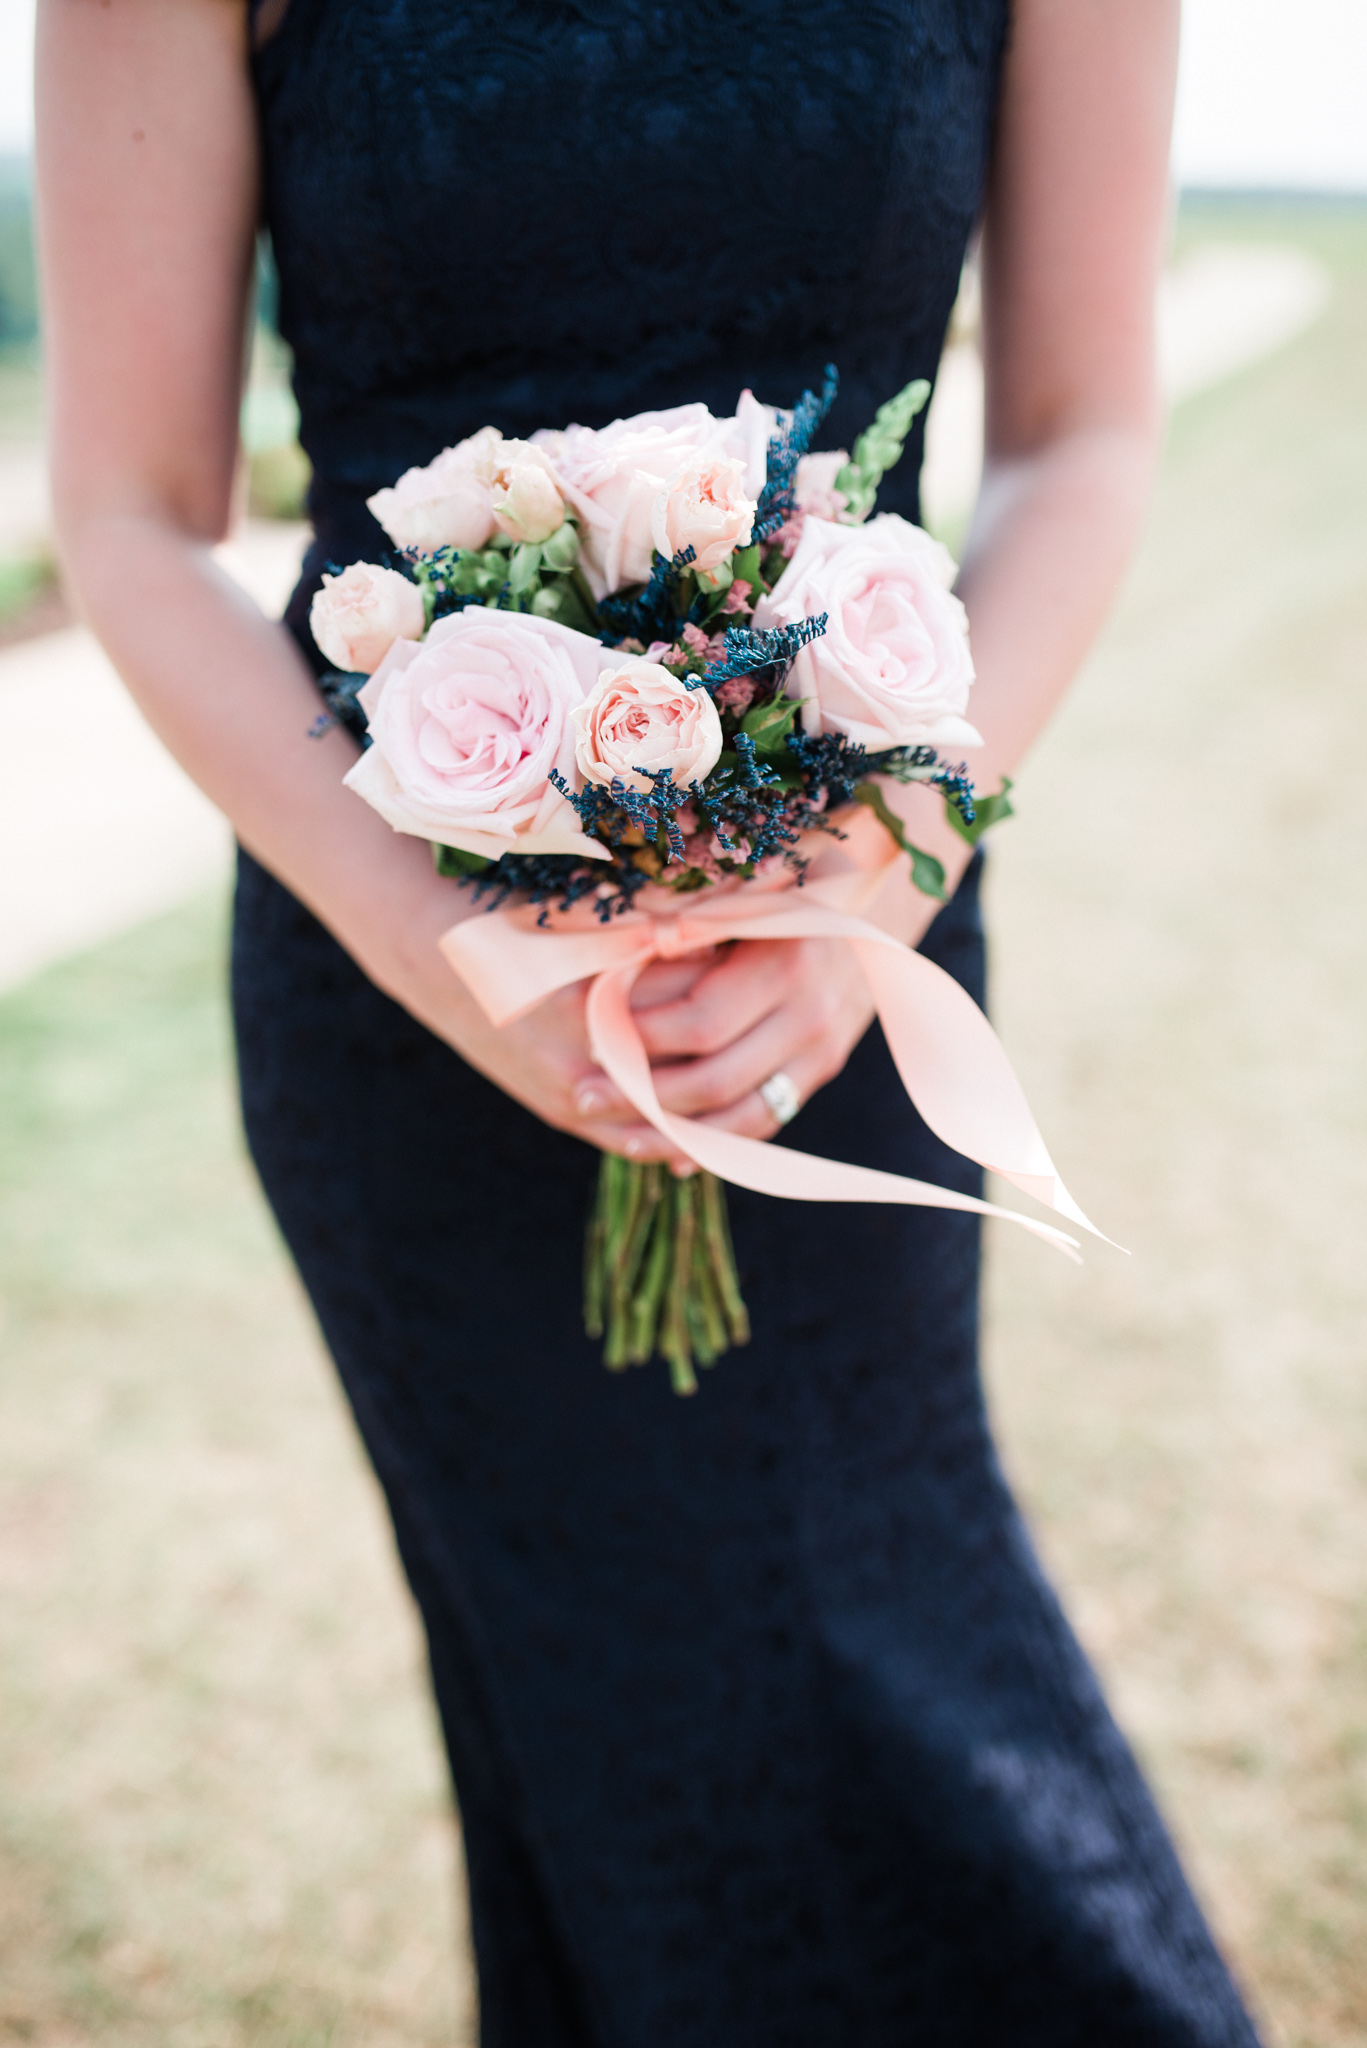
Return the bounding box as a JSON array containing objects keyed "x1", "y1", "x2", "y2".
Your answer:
[{"x1": 639, "y1": 0, "x2": 1178, "y2": 1137}]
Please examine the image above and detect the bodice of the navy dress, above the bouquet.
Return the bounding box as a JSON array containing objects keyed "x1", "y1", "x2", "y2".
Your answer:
[{"x1": 254, "y1": 0, "x2": 1006, "y2": 569}]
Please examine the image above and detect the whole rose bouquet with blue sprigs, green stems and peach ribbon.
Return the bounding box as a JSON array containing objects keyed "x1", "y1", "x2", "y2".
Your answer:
[{"x1": 312, "y1": 371, "x2": 1090, "y2": 1393}]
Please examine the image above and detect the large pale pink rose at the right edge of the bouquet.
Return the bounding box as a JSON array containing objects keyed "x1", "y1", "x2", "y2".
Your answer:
[{"x1": 754, "y1": 512, "x2": 982, "y2": 752}]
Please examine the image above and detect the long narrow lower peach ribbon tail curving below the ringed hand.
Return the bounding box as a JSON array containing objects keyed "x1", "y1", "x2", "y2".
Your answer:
[{"x1": 588, "y1": 961, "x2": 1078, "y2": 1262}]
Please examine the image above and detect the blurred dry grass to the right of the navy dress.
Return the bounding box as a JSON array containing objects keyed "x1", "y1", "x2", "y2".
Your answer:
[{"x1": 988, "y1": 205, "x2": 1367, "y2": 2048}]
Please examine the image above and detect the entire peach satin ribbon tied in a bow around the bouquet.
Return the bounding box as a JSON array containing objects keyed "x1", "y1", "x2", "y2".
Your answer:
[{"x1": 441, "y1": 864, "x2": 1101, "y2": 1260}]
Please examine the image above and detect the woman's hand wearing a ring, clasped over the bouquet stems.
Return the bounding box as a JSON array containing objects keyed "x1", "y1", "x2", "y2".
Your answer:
[{"x1": 576, "y1": 938, "x2": 873, "y2": 1163}]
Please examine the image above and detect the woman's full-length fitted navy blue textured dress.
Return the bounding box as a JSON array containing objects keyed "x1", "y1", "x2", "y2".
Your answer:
[{"x1": 234, "y1": 0, "x2": 1254, "y2": 2048}]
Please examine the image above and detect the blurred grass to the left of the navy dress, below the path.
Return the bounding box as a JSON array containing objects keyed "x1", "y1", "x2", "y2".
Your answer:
[{"x1": 0, "y1": 901, "x2": 467, "y2": 2048}]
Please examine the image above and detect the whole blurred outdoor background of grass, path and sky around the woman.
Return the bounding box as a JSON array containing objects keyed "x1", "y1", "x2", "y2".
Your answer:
[{"x1": 0, "y1": 0, "x2": 1367, "y2": 2048}]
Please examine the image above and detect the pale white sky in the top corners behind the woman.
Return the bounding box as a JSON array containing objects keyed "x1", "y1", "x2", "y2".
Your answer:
[{"x1": 0, "y1": 0, "x2": 1367, "y2": 193}]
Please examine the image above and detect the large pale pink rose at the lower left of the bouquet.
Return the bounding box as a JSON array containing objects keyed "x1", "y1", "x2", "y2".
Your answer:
[{"x1": 346, "y1": 606, "x2": 609, "y2": 860}]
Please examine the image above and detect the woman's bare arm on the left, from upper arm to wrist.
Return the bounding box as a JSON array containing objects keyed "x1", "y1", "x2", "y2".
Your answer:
[{"x1": 37, "y1": 0, "x2": 664, "y2": 1147}]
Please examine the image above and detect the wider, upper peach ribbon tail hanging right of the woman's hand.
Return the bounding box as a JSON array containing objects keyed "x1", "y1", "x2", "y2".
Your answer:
[{"x1": 851, "y1": 936, "x2": 1121, "y2": 1249}]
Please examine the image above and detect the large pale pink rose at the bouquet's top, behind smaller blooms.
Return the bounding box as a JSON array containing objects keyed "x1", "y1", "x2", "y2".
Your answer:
[{"x1": 533, "y1": 391, "x2": 775, "y2": 598}]
